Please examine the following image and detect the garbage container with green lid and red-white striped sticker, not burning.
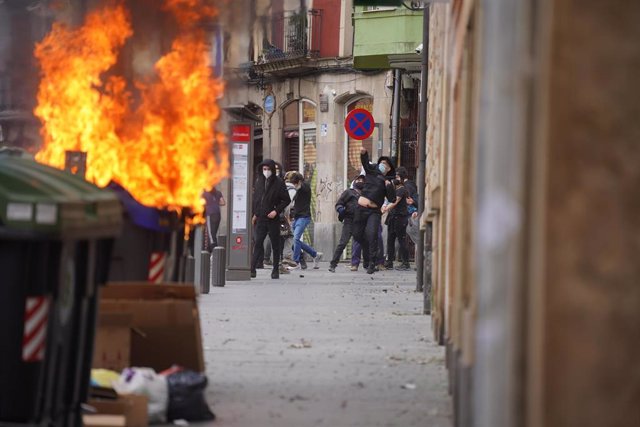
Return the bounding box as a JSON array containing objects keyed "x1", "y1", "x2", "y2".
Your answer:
[{"x1": 0, "y1": 152, "x2": 122, "y2": 426}]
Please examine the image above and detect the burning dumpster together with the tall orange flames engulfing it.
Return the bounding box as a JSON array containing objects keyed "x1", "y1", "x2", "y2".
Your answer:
[{"x1": 29, "y1": 0, "x2": 229, "y2": 282}]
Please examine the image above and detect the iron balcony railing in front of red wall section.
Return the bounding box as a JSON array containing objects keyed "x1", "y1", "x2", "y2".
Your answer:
[{"x1": 258, "y1": 9, "x2": 322, "y2": 64}]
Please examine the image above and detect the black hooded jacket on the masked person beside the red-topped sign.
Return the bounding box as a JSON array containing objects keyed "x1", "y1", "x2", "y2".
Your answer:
[{"x1": 253, "y1": 159, "x2": 291, "y2": 220}]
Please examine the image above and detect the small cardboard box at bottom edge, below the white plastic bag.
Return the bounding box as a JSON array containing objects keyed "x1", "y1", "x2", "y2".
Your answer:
[{"x1": 82, "y1": 394, "x2": 149, "y2": 427}]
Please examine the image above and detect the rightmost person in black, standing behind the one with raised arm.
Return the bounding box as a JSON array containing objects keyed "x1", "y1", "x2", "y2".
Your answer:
[{"x1": 382, "y1": 179, "x2": 410, "y2": 270}]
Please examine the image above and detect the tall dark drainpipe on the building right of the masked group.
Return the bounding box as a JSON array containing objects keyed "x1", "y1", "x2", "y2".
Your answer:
[{"x1": 416, "y1": 4, "x2": 429, "y2": 292}]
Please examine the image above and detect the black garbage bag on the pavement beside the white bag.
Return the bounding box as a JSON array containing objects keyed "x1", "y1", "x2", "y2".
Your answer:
[{"x1": 167, "y1": 370, "x2": 216, "y2": 421}]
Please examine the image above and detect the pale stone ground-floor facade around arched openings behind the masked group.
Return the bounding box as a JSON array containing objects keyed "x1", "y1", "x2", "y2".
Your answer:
[{"x1": 240, "y1": 72, "x2": 393, "y2": 259}]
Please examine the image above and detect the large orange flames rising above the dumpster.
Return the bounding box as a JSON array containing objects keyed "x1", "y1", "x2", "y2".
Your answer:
[{"x1": 35, "y1": 0, "x2": 229, "y2": 217}]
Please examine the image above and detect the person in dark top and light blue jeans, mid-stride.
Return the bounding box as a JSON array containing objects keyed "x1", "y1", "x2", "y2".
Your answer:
[{"x1": 290, "y1": 173, "x2": 322, "y2": 270}]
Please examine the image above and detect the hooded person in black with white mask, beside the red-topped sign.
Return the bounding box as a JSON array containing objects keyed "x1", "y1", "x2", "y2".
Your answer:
[{"x1": 251, "y1": 159, "x2": 291, "y2": 279}]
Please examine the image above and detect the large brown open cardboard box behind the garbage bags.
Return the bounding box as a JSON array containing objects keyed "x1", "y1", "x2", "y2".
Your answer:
[{"x1": 100, "y1": 282, "x2": 204, "y2": 372}]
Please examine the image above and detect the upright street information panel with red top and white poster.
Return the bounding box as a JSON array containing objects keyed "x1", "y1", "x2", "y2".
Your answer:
[{"x1": 226, "y1": 122, "x2": 253, "y2": 281}]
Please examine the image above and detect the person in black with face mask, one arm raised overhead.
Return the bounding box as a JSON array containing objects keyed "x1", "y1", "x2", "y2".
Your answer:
[{"x1": 353, "y1": 148, "x2": 396, "y2": 274}]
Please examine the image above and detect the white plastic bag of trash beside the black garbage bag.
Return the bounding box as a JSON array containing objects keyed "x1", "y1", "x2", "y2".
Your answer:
[{"x1": 113, "y1": 368, "x2": 169, "y2": 424}]
